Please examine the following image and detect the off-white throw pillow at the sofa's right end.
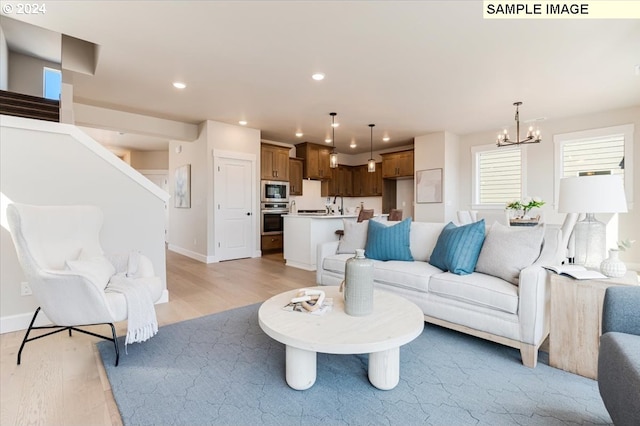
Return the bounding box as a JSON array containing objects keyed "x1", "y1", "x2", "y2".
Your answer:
[{"x1": 476, "y1": 222, "x2": 544, "y2": 285}]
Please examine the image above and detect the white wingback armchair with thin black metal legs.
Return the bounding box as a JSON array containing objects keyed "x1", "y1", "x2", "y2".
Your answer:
[{"x1": 7, "y1": 204, "x2": 163, "y2": 366}]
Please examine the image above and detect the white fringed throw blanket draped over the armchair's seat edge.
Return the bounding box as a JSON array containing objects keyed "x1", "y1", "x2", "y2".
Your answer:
[{"x1": 106, "y1": 273, "x2": 158, "y2": 352}]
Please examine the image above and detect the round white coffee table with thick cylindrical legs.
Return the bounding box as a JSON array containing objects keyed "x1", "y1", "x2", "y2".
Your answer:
[{"x1": 258, "y1": 286, "x2": 424, "y2": 390}]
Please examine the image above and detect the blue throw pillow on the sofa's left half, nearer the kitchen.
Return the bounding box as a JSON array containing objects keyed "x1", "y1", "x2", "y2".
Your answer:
[{"x1": 364, "y1": 217, "x2": 413, "y2": 261}]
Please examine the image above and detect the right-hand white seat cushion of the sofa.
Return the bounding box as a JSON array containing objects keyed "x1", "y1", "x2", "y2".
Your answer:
[{"x1": 429, "y1": 272, "x2": 518, "y2": 314}]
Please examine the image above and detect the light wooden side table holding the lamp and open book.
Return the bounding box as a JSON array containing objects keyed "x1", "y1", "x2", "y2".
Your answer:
[{"x1": 549, "y1": 271, "x2": 638, "y2": 380}]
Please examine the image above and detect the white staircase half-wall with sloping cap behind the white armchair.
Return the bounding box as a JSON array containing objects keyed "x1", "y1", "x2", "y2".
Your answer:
[{"x1": 0, "y1": 116, "x2": 168, "y2": 332}]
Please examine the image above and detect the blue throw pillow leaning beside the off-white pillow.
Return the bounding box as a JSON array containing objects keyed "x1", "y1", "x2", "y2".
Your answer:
[{"x1": 429, "y1": 219, "x2": 485, "y2": 275}]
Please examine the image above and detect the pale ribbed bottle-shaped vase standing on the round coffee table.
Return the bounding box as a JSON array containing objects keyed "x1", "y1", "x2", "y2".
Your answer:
[{"x1": 344, "y1": 249, "x2": 373, "y2": 317}]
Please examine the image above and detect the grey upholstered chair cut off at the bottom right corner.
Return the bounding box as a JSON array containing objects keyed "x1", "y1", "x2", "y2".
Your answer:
[{"x1": 598, "y1": 286, "x2": 640, "y2": 426}]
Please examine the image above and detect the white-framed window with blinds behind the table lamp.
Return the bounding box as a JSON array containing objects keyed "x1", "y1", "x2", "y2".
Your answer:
[{"x1": 553, "y1": 124, "x2": 634, "y2": 203}]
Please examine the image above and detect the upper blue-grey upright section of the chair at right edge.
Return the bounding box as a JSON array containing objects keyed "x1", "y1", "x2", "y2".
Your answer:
[{"x1": 602, "y1": 286, "x2": 640, "y2": 336}]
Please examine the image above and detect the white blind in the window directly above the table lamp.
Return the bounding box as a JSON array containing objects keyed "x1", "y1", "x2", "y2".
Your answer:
[{"x1": 562, "y1": 134, "x2": 624, "y2": 178}]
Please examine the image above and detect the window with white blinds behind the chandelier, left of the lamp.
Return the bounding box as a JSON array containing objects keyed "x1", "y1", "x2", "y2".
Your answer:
[{"x1": 472, "y1": 145, "x2": 525, "y2": 207}]
